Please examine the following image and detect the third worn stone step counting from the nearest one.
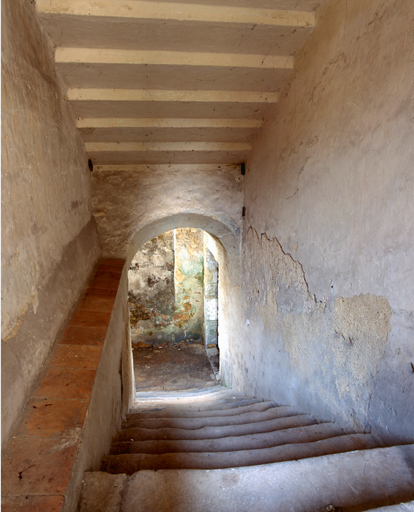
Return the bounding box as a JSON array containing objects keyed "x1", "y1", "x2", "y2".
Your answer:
[{"x1": 110, "y1": 423, "x2": 348, "y2": 455}]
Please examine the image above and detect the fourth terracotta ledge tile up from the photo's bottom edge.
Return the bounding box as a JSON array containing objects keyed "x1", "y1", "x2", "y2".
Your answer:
[{"x1": 34, "y1": 368, "x2": 96, "y2": 400}]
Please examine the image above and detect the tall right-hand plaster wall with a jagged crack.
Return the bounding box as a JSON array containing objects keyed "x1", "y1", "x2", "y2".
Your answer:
[{"x1": 236, "y1": 0, "x2": 414, "y2": 440}]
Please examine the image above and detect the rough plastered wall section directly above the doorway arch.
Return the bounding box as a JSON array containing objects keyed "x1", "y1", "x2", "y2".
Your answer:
[{"x1": 92, "y1": 166, "x2": 243, "y2": 260}]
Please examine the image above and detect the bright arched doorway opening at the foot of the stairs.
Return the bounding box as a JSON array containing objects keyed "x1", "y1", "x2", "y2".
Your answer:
[{"x1": 128, "y1": 228, "x2": 219, "y2": 392}]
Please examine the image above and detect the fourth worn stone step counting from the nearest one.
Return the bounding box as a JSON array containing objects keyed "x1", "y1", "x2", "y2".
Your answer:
[{"x1": 114, "y1": 414, "x2": 317, "y2": 442}]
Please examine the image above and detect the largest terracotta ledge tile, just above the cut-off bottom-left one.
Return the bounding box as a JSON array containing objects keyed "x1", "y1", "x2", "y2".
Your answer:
[{"x1": 2, "y1": 436, "x2": 77, "y2": 496}]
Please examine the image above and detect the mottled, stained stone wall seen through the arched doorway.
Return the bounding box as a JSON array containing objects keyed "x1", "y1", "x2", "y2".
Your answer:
[{"x1": 128, "y1": 228, "x2": 204, "y2": 346}]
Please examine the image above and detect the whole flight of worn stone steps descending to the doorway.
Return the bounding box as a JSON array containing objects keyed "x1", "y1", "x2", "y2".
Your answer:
[{"x1": 80, "y1": 386, "x2": 414, "y2": 512}]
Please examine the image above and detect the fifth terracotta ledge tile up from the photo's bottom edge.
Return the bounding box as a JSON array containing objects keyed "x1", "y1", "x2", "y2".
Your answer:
[{"x1": 50, "y1": 344, "x2": 102, "y2": 370}]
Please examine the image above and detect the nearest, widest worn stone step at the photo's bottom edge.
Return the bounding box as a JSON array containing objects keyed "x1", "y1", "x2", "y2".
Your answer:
[{"x1": 90, "y1": 445, "x2": 414, "y2": 512}]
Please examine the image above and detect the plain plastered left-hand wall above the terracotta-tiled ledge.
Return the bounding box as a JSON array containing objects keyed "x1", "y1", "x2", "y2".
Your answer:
[{"x1": 2, "y1": 0, "x2": 99, "y2": 446}]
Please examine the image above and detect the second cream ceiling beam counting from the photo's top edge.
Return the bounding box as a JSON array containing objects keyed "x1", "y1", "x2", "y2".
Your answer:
[{"x1": 55, "y1": 48, "x2": 294, "y2": 69}]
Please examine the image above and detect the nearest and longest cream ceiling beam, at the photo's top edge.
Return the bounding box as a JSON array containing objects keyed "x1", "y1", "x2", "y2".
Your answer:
[{"x1": 36, "y1": 0, "x2": 315, "y2": 27}]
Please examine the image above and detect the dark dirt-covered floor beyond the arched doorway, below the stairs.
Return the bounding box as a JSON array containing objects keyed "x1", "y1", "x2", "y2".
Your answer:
[{"x1": 133, "y1": 343, "x2": 217, "y2": 392}]
